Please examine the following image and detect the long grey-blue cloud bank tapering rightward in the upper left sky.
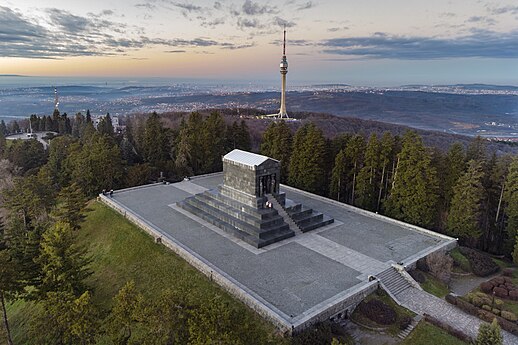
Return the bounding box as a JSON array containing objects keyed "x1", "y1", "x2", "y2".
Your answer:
[{"x1": 0, "y1": 6, "x2": 234, "y2": 59}]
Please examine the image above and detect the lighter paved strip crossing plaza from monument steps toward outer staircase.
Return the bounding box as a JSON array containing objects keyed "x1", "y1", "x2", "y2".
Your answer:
[{"x1": 295, "y1": 233, "x2": 390, "y2": 274}]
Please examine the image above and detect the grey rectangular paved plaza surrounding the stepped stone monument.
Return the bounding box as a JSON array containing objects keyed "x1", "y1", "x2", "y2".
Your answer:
[{"x1": 105, "y1": 174, "x2": 454, "y2": 328}]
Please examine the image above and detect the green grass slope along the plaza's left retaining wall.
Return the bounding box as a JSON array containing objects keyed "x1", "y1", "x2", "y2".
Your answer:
[{"x1": 9, "y1": 202, "x2": 288, "y2": 344}]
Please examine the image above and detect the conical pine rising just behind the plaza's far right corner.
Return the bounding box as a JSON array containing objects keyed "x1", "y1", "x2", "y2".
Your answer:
[{"x1": 447, "y1": 160, "x2": 490, "y2": 243}]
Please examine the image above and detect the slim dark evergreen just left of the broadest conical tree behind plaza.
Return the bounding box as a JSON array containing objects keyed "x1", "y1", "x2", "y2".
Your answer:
[{"x1": 355, "y1": 134, "x2": 381, "y2": 211}]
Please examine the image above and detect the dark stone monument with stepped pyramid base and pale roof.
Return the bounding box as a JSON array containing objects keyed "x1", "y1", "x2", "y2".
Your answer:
[{"x1": 178, "y1": 150, "x2": 333, "y2": 248}]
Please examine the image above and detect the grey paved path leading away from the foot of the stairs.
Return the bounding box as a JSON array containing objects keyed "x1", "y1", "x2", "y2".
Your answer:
[{"x1": 396, "y1": 288, "x2": 518, "y2": 345}]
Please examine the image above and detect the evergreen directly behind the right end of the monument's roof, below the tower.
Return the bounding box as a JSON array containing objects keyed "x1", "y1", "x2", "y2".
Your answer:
[{"x1": 260, "y1": 121, "x2": 293, "y2": 183}]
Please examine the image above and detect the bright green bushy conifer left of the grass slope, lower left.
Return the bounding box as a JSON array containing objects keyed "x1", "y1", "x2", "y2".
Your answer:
[{"x1": 37, "y1": 221, "x2": 91, "y2": 296}]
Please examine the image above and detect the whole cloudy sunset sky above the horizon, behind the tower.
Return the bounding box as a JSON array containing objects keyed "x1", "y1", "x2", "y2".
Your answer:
[{"x1": 0, "y1": 0, "x2": 518, "y2": 86}]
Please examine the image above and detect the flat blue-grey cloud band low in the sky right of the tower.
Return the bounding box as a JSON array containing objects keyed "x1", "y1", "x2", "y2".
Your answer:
[{"x1": 321, "y1": 29, "x2": 518, "y2": 60}]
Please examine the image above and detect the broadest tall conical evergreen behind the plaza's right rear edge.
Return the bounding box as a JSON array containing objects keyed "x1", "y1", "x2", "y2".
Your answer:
[{"x1": 385, "y1": 131, "x2": 438, "y2": 227}]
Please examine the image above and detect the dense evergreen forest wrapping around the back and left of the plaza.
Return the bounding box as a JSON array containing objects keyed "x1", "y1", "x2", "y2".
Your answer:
[{"x1": 0, "y1": 111, "x2": 518, "y2": 344}]
